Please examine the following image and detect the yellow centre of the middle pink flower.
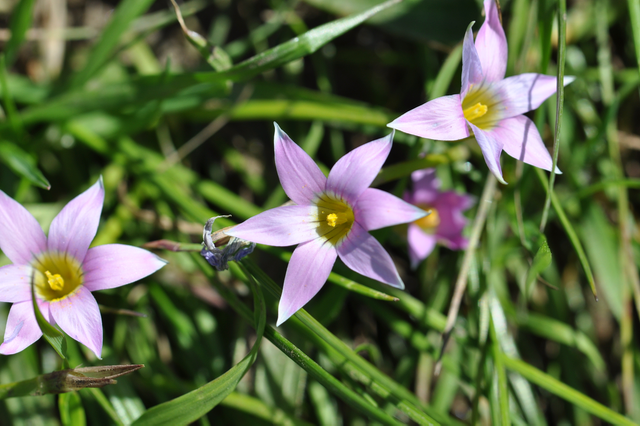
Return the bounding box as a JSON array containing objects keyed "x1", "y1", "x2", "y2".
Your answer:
[{"x1": 316, "y1": 194, "x2": 355, "y2": 246}]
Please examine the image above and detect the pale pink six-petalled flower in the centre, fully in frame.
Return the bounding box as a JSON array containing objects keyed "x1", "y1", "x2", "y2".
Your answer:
[{"x1": 225, "y1": 124, "x2": 426, "y2": 325}]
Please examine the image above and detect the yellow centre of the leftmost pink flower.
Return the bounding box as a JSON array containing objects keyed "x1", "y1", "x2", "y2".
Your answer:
[{"x1": 32, "y1": 252, "x2": 84, "y2": 302}]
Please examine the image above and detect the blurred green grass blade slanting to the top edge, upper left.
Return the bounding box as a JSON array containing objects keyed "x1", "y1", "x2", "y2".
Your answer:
[{"x1": 71, "y1": 0, "x2": 153, "y2": 87}]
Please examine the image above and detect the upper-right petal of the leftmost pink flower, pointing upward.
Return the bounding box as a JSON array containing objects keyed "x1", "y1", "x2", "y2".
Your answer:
[{"x1": 49, "y1": 176, "x2": 104, "y2": 262}]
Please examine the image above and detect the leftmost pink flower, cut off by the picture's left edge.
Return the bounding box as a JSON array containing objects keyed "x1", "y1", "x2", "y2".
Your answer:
[{"x1": 0, "y1": 178, "x2": 166, "y2": 358}]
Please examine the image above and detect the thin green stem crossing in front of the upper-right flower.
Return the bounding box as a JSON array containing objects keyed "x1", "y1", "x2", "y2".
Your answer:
[{"x1": 540, "y1": 0, "x2": 567, "y2": 232}]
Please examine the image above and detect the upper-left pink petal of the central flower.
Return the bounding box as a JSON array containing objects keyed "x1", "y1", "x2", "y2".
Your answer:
[{"x1": 273, "y1": 123, "x2": 327, "y2": 205}]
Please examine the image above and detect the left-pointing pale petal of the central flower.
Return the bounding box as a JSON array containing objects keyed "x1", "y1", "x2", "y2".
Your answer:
[{"x1": 225, "y1": 205, "x2": 319, "y2": 247}]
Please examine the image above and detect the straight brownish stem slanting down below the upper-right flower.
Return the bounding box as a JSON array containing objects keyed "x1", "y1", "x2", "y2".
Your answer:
[{"x1": 435, "y1": 173, "x2": 498, "y2": 375}]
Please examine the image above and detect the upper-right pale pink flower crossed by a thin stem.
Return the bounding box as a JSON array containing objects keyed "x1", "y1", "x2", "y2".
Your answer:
[{"x1": 388, "y1": 0, "x2": 574, "y2": 184}]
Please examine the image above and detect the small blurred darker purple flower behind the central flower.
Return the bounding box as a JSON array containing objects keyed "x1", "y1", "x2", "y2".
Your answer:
[{"x1": 403, "y1": 169, "x2": 473, "y2": 268}]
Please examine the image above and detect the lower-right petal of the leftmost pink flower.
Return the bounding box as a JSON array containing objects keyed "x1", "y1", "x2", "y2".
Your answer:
[{"x1": 49, "y1": 286, "x2": 102, "y2": 359}]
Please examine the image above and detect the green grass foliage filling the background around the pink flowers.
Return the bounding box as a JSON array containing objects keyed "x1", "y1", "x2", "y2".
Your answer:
[{"x1": 0, "y1": 0, "x2": 640, "y2": 425}]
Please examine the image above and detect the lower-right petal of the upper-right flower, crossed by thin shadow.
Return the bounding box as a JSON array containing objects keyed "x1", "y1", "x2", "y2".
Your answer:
[{"x1": 490, "y1": 115, "x2": 562, "y2": 174}]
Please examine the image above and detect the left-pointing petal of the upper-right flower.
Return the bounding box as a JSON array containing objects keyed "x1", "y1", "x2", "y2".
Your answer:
[{"x1": 387, "y1": 95, "x2": 469, "y2": 141}]
